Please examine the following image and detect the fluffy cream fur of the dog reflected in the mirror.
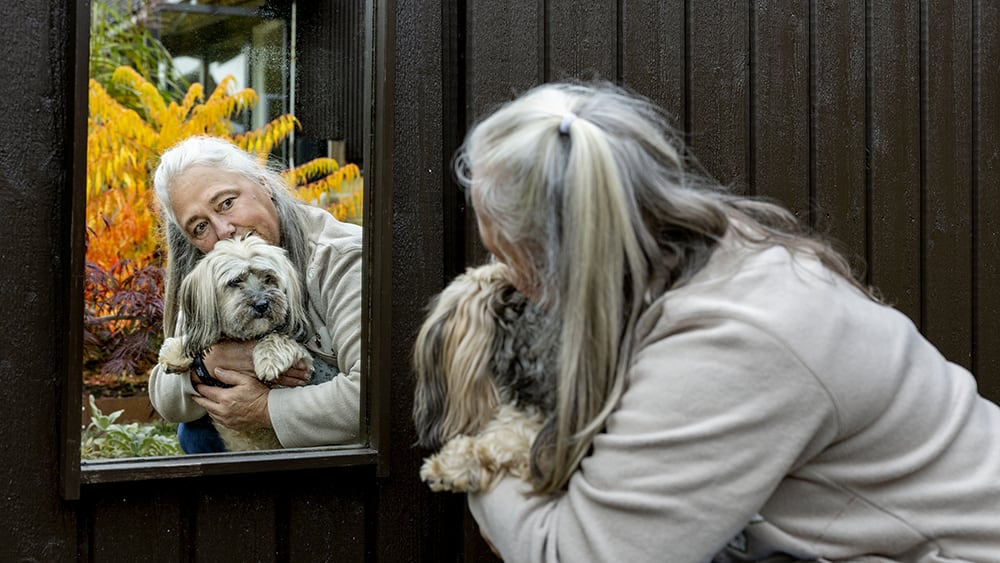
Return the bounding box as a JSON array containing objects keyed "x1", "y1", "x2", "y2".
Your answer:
[{"x1": 159, "y1": 235, "x2": 313, "y2": 451}]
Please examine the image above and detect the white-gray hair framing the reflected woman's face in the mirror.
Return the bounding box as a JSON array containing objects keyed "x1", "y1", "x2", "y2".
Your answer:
[{"x1": 153, "y1": 136, "x2": 309, "y2": 337}]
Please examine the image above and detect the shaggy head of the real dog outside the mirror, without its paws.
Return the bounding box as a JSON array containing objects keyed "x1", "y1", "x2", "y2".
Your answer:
[{"x1": 413, "y1": 263, "x2": 549, "y2": 450}]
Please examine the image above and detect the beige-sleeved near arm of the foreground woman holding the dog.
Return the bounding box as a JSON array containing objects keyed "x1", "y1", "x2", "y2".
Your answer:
[{"x1": 469, "y1": 319, "x2": 837, "y2": 562}]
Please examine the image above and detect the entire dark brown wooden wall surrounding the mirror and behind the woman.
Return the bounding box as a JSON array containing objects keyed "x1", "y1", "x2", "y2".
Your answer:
[{"x1": 0, "y1": 0, "x2": 1000, "y2": 562}]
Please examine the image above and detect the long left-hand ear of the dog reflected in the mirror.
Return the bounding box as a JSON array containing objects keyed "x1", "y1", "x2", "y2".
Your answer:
[{"x1": 179, "y1": 267, "x2": 222, "y2": 357}]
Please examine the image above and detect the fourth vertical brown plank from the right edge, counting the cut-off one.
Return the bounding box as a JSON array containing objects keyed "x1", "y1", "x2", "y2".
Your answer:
[{"x1": 811, "y1": 0, "x2": 868, "y2": 273}]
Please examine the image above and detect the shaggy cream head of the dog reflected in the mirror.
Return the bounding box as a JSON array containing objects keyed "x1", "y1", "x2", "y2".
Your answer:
[{"x1": 179, "y1": 236, "x2": 305, "y2": 355}]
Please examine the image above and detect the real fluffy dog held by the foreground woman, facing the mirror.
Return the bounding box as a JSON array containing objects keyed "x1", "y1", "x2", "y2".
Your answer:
[{"x1": 413, "y1": 263, "x2": 554, "y2": 492}]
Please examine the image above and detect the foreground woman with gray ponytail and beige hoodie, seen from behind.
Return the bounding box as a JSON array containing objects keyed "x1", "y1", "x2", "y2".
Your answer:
[{"x1": 456, "y1": 84, "x2": 1000, "y2": 562}]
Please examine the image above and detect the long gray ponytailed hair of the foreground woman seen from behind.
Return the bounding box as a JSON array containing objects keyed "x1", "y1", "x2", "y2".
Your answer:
[{"x1": 455, "y1": 83, "x2": 871, "y2": 493}]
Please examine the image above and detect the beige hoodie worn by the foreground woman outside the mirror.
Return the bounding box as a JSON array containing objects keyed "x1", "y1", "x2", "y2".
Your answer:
[{"x1": 469, "y1": 240, "x2": 1000, "y2": 563}]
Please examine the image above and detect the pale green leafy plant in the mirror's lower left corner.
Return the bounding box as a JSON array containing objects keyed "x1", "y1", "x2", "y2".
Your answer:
[{"x1": 80, "y1": 395, "x2": 184, "y2": 459}]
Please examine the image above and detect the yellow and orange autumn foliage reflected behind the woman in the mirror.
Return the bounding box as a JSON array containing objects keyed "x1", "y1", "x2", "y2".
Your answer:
[{"x1": 84, "y1": 66, "x2": 363, "y2": 392}]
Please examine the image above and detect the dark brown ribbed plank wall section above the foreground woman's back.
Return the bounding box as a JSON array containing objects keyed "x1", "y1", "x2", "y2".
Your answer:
[{"x1": 464, "y1": 0, "x2": 1000, "y2": 406}]
